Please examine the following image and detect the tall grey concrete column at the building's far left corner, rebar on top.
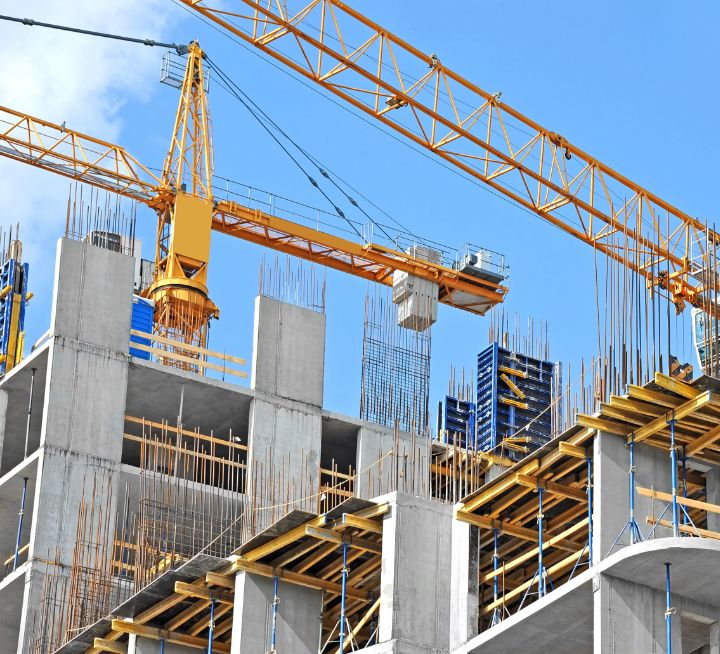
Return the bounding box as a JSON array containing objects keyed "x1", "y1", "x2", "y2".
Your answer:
[{"x1": 18, "y1": 239, "x2": 133, "y2": 652}]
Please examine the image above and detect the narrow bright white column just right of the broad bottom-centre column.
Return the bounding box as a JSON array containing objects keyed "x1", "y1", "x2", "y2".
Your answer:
[{"x1": 450, "y1": 520, "x2": 480, "y2": 651}]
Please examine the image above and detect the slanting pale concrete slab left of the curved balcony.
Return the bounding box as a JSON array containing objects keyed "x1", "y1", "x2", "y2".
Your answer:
[{"x1": 453, "y1": 570, "x2": 593, "y2": 654}]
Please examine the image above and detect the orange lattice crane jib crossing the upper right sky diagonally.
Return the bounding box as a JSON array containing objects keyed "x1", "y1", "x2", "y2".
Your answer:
[{"x1": 180, "y1": 0, "x2": 718, "y2": 310}]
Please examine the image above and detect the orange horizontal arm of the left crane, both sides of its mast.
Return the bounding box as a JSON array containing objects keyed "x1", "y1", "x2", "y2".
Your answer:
[{"x1": 0, "y1": 106, "x2": 507, "y2": 314}]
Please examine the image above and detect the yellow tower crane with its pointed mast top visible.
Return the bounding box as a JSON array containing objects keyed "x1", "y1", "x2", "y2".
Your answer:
[{"x1": 0, "y1": 42, "x2": 507, "y2": 366}]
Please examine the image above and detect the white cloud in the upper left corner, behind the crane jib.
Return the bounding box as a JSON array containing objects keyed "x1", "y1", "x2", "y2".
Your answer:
[{"x1": 0, "y1": 0, "x2": 177, "y2": 318}]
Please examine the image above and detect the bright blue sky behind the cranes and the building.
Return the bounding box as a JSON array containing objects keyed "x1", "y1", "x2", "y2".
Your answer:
[{"x1": 0, "y1": 0, "x2": 720, "y2": 422}]
